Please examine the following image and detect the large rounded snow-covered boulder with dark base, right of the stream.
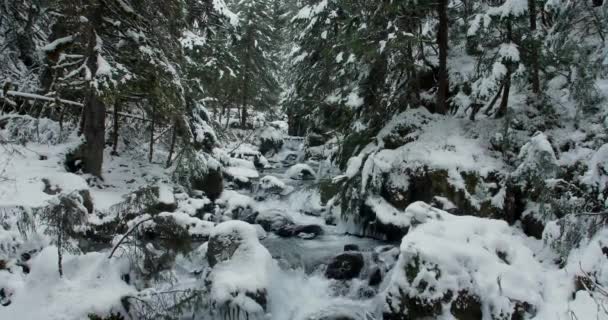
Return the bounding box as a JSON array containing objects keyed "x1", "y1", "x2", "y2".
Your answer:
[{"x1": 383, "y1": 203, "x2": 543, "y2": 320}]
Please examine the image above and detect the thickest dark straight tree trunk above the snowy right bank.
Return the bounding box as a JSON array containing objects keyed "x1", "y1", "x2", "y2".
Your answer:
[{"x1": 435, "y1": 0, "x2": 449, "y2": 114}]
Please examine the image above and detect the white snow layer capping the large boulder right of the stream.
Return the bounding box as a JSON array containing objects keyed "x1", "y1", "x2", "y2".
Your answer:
[{"x1": 385, "y1": 205, "x2": 544, "y2": 316}]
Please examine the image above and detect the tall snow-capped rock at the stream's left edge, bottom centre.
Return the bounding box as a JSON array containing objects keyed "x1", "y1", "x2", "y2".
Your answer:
[{"x1": 206, "y1": 221, "x2": 272, "y2": 320}]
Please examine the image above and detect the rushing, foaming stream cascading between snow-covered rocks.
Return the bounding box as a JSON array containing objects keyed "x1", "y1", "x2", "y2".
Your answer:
[{"x1": 223, "y1": 142, "x2": 394, "y2": 320}]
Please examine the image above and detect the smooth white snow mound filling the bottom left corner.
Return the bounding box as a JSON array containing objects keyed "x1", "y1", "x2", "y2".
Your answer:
[{"x1": 0, "y1": 246, "x2": 135, "y2": 320}]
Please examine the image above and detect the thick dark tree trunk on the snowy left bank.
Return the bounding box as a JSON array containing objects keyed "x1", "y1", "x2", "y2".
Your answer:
[{"x1": 83, "y1": 2, "x2": 106, "y2": 178}]
